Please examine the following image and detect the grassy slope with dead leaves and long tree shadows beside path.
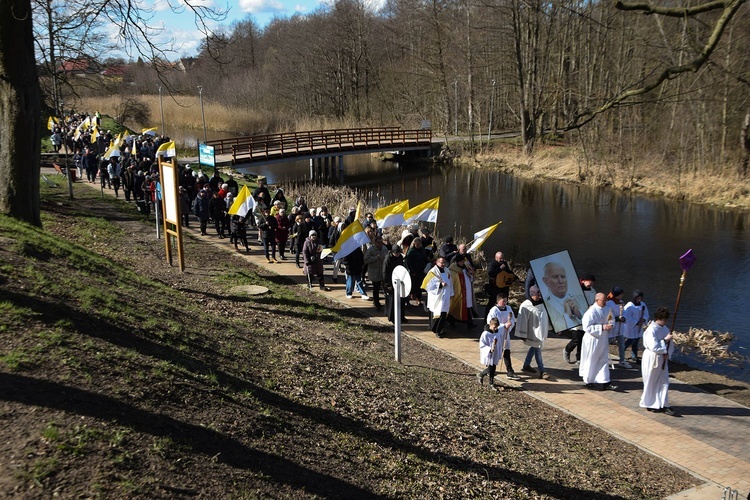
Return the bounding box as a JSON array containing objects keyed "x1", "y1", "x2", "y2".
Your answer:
[{"x1": 0, "y1": 186, "x2": 695, "y2": 498}]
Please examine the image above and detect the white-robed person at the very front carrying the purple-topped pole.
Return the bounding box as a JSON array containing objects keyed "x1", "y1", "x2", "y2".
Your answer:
[{"x1": 640, "y1": 307, "x2": 675, "y2": 415}]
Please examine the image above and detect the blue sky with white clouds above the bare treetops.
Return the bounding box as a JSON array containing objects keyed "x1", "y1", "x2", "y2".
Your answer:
[{"x1": 135, "y1": 0, "x2": 384, "y2": 56}]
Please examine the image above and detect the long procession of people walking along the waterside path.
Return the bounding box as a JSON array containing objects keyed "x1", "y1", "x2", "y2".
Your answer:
[{"x1": 50, "y1": 113, "x2": 675, "y2": 415}]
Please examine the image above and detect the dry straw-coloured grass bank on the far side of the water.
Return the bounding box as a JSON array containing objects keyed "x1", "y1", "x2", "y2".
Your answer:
[{"x1": 451, "y1": 142, "x2": 750, "y2": 211}]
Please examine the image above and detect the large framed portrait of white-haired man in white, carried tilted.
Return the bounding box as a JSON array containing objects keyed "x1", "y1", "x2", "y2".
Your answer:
[{"x1": 529, "y1": 250, "x2": 589, "y2": 334}]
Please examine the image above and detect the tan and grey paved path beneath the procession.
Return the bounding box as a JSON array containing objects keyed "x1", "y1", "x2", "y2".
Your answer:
[{"x1": 66, "y1": 171, "x2": 750, "y2": 499}]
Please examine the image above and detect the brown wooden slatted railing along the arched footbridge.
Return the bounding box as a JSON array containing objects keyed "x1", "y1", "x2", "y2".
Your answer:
[{"x1": 219, "y1": 127, "x2": 432, "y2": 163}]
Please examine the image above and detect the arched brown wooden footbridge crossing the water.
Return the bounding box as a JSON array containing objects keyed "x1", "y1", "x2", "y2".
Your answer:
[{"x1": 206, "y1": 127, "x2": 432, "y2": 171}]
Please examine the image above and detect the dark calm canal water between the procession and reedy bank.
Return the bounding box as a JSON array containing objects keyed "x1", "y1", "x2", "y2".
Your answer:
[{"x1": 236, "y1": 155, "x2": 750, "y2": 381}]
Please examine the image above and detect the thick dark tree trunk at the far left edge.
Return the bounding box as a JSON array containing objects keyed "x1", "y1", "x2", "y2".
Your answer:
[{"x1": 0, "y1": 0, "x2": 41, "y2": 226}]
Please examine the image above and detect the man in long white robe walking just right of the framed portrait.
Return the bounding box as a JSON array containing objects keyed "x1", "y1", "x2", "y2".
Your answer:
[{"x1": 578, "y1": 293, "x2": 617, "y2": 390}]
